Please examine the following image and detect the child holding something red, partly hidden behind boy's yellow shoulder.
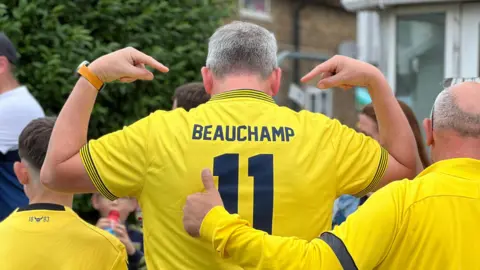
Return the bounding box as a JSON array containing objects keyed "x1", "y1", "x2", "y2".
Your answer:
[{"x1": 92, "y1": 193, "x2": 146, "y2": 270}]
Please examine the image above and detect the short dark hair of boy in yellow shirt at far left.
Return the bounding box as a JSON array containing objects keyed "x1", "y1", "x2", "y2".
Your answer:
[{"x1": 18, "y1": 117, "x2": 55, "y2": 172}]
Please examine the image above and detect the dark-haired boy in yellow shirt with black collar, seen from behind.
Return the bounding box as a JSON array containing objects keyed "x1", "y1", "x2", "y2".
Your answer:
[{"x1": 0, "y1": 118, "x2": 127, "y2": 270}]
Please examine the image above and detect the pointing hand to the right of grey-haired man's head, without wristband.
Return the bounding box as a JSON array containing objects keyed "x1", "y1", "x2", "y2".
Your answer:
[{"x1": 301, "y1": 55, "x2": 383, "y2": 90}]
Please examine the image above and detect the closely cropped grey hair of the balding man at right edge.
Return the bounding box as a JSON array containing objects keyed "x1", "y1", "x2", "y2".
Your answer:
[{"x1": 432, "y1": 88, "x2": 480, "y2": 138}]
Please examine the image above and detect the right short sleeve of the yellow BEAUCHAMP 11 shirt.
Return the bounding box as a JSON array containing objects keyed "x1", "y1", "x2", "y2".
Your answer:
[{"x1": 329, "y1": 120, "x2": 388, "y2": 197}]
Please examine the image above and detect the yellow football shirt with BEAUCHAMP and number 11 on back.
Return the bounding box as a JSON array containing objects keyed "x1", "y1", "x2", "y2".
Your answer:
[{"x1": 81, "y1": 90, "x2": 388, "y2": 269}]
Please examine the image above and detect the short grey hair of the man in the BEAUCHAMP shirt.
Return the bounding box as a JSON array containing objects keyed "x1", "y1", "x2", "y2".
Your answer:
[{"x1": 207, "y1": 21, "x2": 277, "y2": 79}]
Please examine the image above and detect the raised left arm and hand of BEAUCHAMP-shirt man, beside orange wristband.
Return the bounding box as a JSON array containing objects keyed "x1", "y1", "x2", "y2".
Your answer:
[{"x1": 41, "y1": 48, "x2": 168, "y2": 193}]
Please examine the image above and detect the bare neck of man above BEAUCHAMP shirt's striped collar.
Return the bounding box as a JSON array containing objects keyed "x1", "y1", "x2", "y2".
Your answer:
[{"x1": 212, "y1": 75, "x2": 272, "y2": 96}]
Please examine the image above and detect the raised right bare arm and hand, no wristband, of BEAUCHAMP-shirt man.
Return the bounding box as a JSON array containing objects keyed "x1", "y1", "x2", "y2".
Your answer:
[{"x1": 302, "y1": 56, "x2": 417, "y2": 188}]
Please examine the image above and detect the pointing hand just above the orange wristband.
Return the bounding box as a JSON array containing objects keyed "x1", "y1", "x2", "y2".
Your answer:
[{"x1": 88, "y1": 47, "x2": 168, "y2": 83}]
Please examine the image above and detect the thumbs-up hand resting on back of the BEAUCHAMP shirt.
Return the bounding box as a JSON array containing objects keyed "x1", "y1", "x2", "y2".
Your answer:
[{"x1": 183, "y1": 169, "x2": 223, "y2": 237}]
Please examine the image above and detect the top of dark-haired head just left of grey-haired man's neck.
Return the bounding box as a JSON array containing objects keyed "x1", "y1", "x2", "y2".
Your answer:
[{"x1": 173, "y1": 82, "x2": 210, "y2": 111}]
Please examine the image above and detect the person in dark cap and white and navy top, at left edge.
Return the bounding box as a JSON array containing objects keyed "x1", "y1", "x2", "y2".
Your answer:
[{"x1": 0, "y1": 32, "x2": 44, "y2": 221}]
